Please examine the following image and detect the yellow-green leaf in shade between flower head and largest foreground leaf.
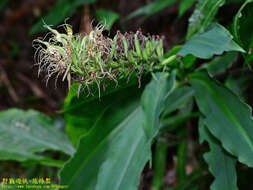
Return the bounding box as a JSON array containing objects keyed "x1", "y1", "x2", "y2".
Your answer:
[{"x1": 64, "y1": 86, "x2": 140, "y2": 146}]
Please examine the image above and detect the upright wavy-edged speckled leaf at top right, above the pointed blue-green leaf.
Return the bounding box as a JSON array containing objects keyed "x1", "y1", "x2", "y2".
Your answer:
[{"x1": 187, "y1": 0, "x2": 225, "y2": 39}]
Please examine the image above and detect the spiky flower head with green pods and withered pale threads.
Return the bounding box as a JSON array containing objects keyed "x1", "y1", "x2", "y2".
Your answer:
[{"x1": 34, "y1": 25, "x2": 163, "y2": 95}]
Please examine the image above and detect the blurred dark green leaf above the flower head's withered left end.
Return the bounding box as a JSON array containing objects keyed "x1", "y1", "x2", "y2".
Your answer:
[{"x1": 29, "y1": 0, "x2": 96, "y2": 35}]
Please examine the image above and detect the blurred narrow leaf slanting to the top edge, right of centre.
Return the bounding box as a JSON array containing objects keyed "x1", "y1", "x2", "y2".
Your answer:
[{"x1": 123, "y1": 0, "x2": 177, "y2": 21}]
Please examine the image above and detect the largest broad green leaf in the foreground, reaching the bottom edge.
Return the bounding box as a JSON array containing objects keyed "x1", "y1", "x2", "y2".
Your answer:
[{"x1": 60, "y1": 74, "x2": 176, "y2": 190}]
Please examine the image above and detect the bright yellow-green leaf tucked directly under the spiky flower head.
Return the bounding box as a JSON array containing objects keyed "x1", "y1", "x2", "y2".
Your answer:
[{"x1": 62, "y1": 75, "x2": 142, "y2": 146}]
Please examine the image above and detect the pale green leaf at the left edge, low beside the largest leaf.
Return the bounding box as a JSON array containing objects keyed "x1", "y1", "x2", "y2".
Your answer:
[{"x1": 0, "y1": 109, "x2": 75, "y2": 165}]
